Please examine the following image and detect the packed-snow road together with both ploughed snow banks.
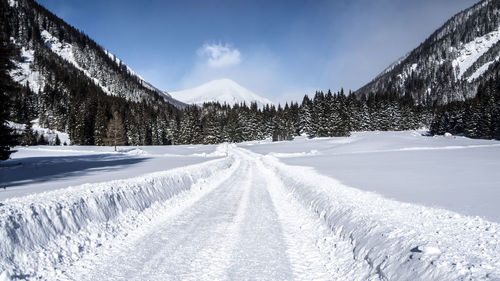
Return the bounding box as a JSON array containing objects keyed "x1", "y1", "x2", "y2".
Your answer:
[{"x1": 0, "y1": 143, "x2": 500, "y2": 280}]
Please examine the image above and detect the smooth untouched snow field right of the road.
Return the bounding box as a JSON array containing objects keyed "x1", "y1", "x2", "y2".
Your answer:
[{"x1": 241, "y1": 131, "x2": 500, "y2": 222}]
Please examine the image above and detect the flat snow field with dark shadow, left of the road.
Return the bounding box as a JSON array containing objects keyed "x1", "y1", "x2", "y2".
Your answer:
[{"x1": 0, "y1": 145, "x2": 225, "y2": 200}]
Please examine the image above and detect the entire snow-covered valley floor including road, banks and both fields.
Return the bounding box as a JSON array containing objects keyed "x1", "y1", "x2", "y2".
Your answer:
[{"x1": 0, "y1": 131, "x2": 500, "y2": 280}]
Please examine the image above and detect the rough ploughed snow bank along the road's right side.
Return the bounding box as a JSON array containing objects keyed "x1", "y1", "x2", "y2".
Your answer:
[{"x1": 262, "y1": 156, "x2": 500, "y2": 280}]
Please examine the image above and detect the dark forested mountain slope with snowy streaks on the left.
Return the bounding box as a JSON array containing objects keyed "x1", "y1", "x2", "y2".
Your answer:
[{"x1": 0, "y1": 0, "x2": 185, "y2": 145}]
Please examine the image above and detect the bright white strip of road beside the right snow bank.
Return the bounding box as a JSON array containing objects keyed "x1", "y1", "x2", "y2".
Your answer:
[{"x1": 257, "y1": 155, "x2": 378, "y2": 280}]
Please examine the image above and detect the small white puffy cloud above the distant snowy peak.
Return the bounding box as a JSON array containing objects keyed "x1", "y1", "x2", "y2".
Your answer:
[{"x1": 198, "y1": 43, "x2": 241, "y2": 68}]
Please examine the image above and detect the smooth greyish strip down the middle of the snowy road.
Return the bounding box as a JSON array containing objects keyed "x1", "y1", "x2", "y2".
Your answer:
[{"x1": 228, "y1": 161, "x2": 293, "y2": 280}]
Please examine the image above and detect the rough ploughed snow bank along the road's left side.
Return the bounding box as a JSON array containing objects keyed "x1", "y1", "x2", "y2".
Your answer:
[{"x1": 0, "y1": 157, "x2": 237, "y2": 279}]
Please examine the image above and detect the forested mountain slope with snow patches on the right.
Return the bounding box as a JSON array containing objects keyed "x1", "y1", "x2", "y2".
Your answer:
[{"x1": 356, "y1": 0, "x2": 500, "y2": 104}]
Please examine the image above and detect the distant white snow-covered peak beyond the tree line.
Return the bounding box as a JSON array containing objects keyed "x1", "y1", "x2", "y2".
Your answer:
[{"x1": 170, "y1": 78, "x2": 272, "y2": 108}]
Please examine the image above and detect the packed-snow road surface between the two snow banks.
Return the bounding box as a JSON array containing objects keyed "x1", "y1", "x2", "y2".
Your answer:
[{"x1": 62, "y1": 150, "x2": 331, "y2": 280}]
